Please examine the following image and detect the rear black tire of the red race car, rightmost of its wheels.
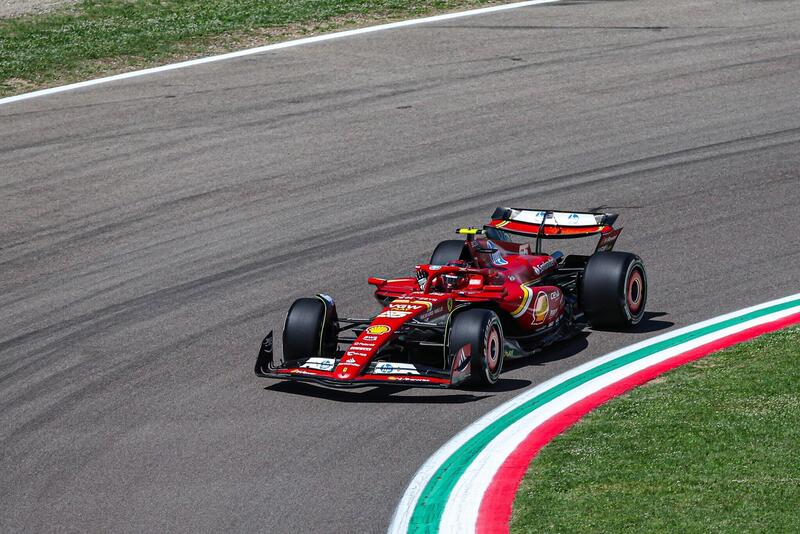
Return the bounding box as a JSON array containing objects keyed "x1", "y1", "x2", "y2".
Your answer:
[{"x1": 581, "y1": 252, "x2": 647, "y2": 329}]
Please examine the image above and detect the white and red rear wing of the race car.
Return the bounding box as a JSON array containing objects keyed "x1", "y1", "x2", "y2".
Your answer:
[{"x1": 485, "y1": 208, "x2": 622, "y2": 252}]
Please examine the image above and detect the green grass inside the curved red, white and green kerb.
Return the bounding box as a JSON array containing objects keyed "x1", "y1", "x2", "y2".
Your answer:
[{"x1": 511, "y1": 328, "x2": 800, "y2": 533}]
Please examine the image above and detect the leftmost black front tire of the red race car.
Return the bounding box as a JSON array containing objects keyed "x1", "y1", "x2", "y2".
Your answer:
[{"x1": 283, "y1": 298, "x2": 335, "y2": 361}]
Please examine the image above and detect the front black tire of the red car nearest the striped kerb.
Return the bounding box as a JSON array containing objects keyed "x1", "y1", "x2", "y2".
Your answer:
[{"x1": 447, "y1": 308, "x2": 503, "y2": 386}]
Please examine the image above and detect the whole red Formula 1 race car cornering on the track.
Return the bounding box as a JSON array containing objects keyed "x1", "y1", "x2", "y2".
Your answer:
[{"x1": 255, "y1": 208, "x2": 647, "y2": 387}]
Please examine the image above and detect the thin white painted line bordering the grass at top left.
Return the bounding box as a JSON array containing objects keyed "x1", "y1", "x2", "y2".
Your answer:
[{"x1": 0, "y1": 0, "x2": 559, "y2": 105}]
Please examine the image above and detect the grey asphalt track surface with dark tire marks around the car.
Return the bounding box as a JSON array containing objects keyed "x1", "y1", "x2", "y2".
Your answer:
[{"x1": 0, "y1": 0, "x2": 800, "y2": 532}]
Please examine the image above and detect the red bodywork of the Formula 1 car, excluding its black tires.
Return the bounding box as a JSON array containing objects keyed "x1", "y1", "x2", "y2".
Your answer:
[{"x1": 256, "y1": 208, "x2": 620, "y2": 387}]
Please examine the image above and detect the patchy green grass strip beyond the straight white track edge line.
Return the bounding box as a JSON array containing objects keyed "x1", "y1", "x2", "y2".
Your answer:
[{"x1": 0, "y1": 0, "x2": 500, "y2": 95}]
